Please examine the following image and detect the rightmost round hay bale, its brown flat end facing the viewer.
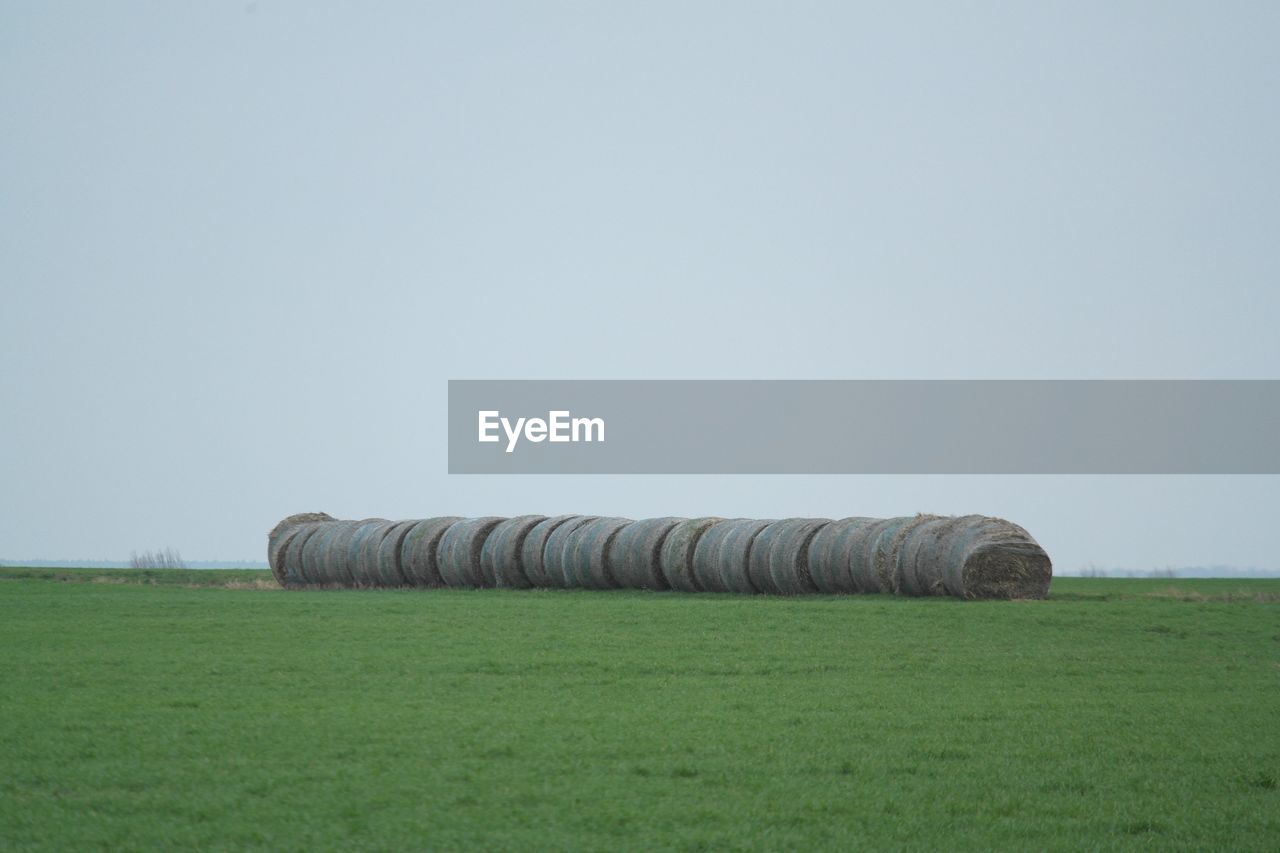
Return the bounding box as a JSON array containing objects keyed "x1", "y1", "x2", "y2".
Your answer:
[{"x1": 943, "y1": 516, "x2": 1053, "y2": 598}]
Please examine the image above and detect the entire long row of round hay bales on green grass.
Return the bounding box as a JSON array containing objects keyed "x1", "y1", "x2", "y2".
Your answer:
[{"x1": 268, "y1": 512, "x2": 1053, "y2": 598}]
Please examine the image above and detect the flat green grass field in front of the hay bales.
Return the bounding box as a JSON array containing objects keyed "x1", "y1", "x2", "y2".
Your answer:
[{"x1": 0, "y1": 569, "x2": 1280, "y2": 850}]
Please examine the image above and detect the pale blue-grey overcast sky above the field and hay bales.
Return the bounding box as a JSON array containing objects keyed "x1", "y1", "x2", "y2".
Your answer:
[{"x1": 0, "y1": 0, "x2": 1280, "y2": 574}]
